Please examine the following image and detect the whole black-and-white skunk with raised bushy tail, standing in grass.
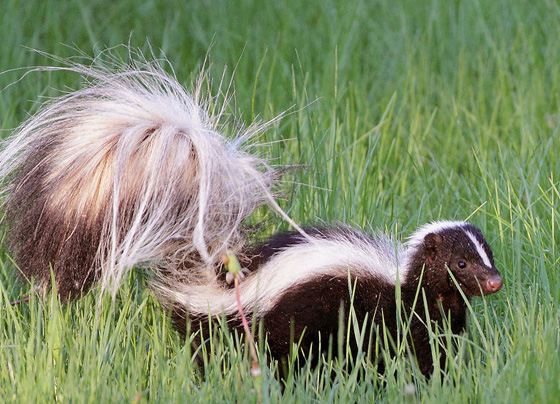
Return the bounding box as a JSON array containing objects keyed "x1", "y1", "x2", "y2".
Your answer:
[{"x1": 0, "y1": 59, "x2": 502, "y2": 374}]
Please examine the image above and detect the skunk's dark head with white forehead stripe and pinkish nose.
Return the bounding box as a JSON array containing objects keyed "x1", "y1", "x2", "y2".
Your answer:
[{"x1": 408, "y1": 222, "x2": 502, "y2": 296}]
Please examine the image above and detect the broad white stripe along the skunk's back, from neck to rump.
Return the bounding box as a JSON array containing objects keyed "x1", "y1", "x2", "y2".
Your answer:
[{"x1": 154, "y1": 229, "x2": 406, "y2": 316}]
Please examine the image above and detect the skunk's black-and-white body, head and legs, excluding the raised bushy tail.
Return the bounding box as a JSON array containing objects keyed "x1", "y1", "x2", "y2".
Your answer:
[{"x1": 171, "y1": 221, "x2": 502, "y2": 375}]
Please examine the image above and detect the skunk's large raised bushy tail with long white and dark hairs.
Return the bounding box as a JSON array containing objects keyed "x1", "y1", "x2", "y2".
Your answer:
[{"x1": 0, "y1": 58, "x2": 298, "y2": 297}]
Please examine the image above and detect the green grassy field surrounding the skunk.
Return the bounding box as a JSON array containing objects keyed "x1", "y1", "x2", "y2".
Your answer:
[{"x1": 0, "y1": 0, "x2": 560, "y2": 403}]
